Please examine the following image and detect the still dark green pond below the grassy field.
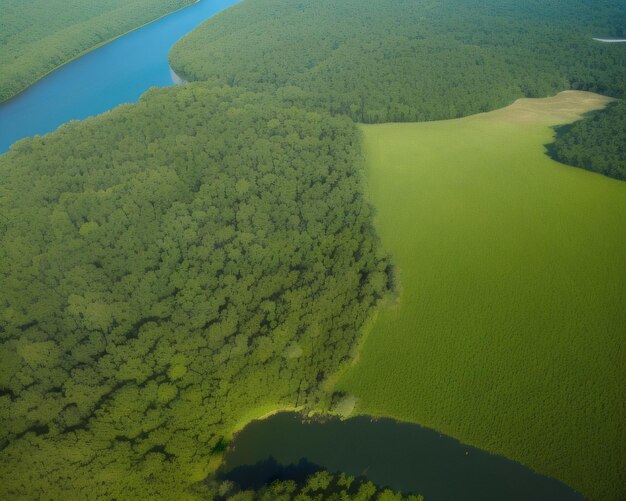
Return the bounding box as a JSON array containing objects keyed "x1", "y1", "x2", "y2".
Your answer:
[{"x1": 218, "y1": 413, "x2": 584, "y2": 501}]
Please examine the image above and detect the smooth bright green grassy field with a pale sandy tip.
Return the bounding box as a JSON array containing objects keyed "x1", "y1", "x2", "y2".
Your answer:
[{"x1": 337, "y1": 92, "x2": 626, "y2": 500}]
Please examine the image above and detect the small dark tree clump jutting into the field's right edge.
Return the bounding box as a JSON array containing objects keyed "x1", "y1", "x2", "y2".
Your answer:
[{"x1": 549, "y1": 100, "x2": 626, "y2": 180}]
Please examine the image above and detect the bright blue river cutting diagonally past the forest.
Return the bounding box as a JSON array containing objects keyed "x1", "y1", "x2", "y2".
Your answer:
[{"x1": 0, "y1": 0, "x2": 239, "y2": 153}]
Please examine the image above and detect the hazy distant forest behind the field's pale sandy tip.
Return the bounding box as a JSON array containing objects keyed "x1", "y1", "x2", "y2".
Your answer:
[{"x1": 171, "y1": 0, "x2": 626, "y2": 123}]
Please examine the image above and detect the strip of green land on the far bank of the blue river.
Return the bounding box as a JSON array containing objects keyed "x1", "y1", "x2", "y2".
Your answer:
[{"x1": 0, "y1": 0, "x2": 193, "y2": 102}]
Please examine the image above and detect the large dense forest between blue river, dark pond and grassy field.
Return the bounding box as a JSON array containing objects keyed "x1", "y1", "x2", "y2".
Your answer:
[{"x1": 0, "y1": 85, "x2": 388, "y2": 499}]
